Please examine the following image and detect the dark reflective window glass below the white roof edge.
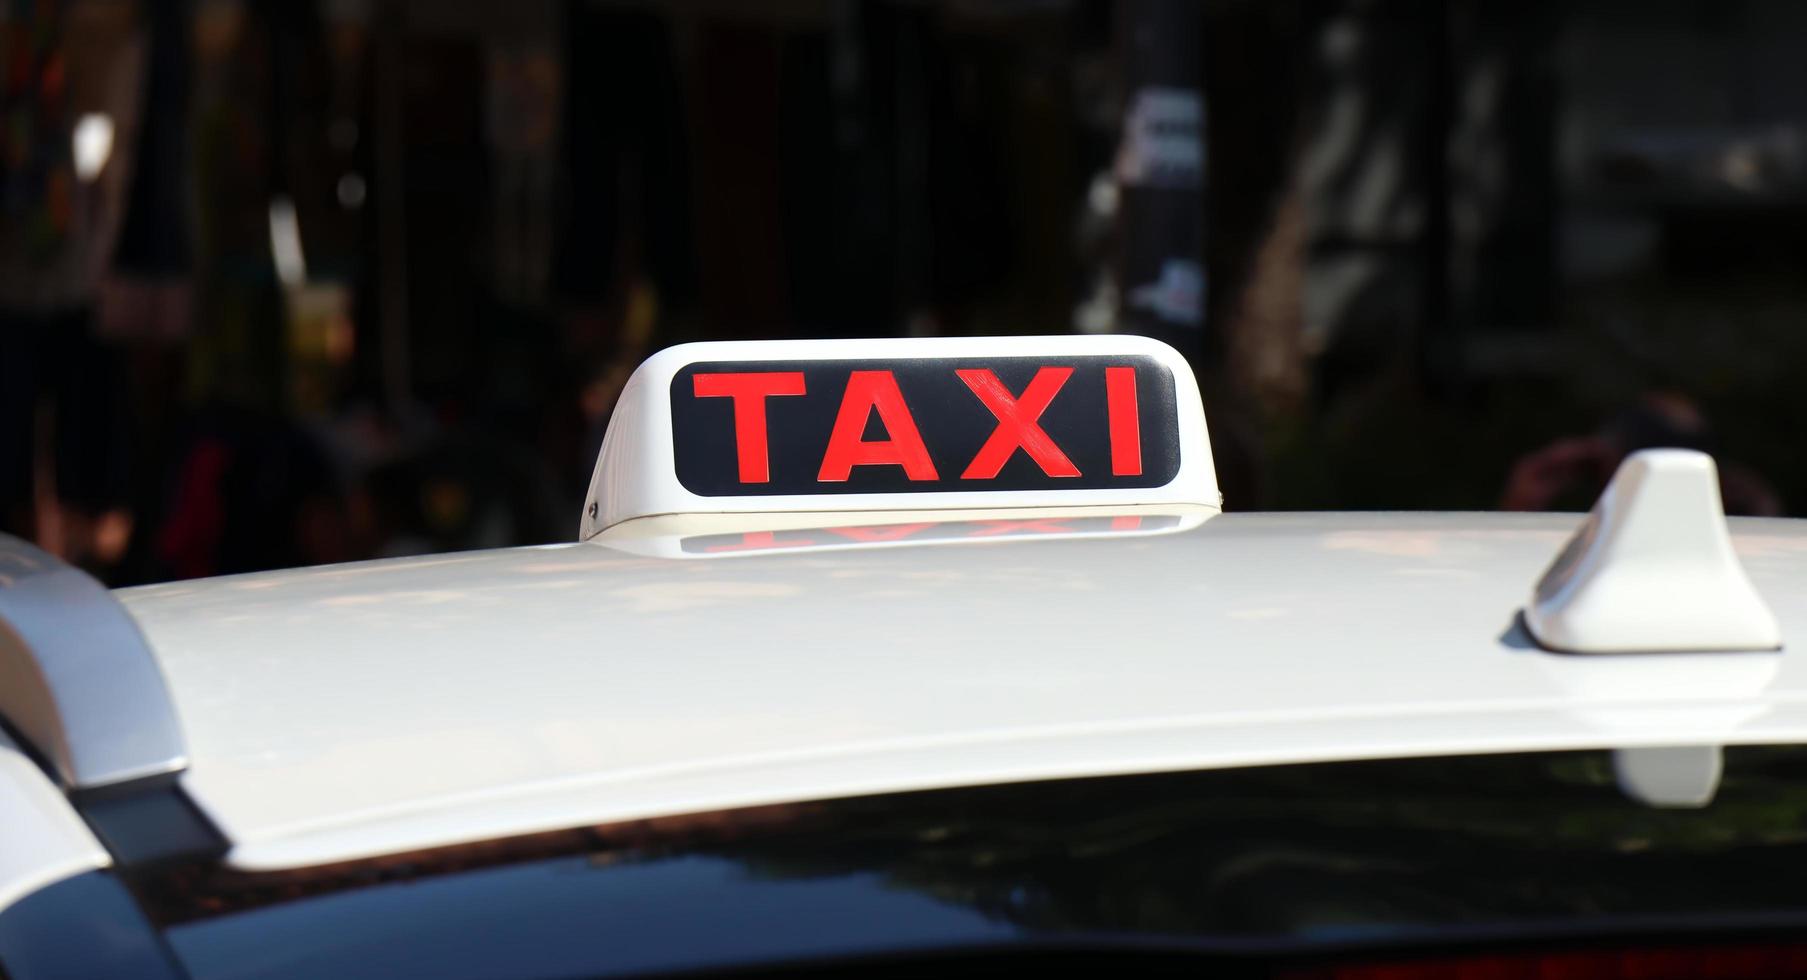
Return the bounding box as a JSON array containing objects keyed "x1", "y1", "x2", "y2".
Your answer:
[{"x1": 146, "y1": 747, "x2": 1807, "y2": 976}]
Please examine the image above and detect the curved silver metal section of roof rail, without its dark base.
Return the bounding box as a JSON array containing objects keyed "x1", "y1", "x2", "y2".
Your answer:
[{"x1": 0, "y1": 535, "x2": 188, "y2": 792}]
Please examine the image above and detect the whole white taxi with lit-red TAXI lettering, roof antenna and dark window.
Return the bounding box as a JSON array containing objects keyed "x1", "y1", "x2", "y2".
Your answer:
[{"x1": 0, "y1": 336, "x2": 1807, "y2": 980}]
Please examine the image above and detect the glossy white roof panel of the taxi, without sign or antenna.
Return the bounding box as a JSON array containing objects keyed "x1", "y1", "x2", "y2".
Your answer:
[{"x1": 116, "y1": 514, "x2": 1807, "y2": 868}]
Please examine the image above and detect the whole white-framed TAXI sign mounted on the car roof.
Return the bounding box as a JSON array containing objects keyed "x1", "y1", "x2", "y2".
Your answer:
[{"x1": 580, "y1": 336, "x2": 1222, "y2": 539}]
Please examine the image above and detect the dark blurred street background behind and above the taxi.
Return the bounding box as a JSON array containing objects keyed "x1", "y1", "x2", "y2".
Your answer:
[{"x1": 0, "y1": 0, "x2": 1807, "y2": 584}]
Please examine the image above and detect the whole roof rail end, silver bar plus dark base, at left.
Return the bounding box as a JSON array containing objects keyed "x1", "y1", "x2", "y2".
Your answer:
[{"x1": 0, "y1": 535, "x2": 220, "y2": 864}]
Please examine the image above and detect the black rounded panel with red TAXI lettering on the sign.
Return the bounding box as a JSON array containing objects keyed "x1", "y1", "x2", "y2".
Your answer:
[{"x1": 670, "y1": 354, "x2": 1180, "y2": 497}]
